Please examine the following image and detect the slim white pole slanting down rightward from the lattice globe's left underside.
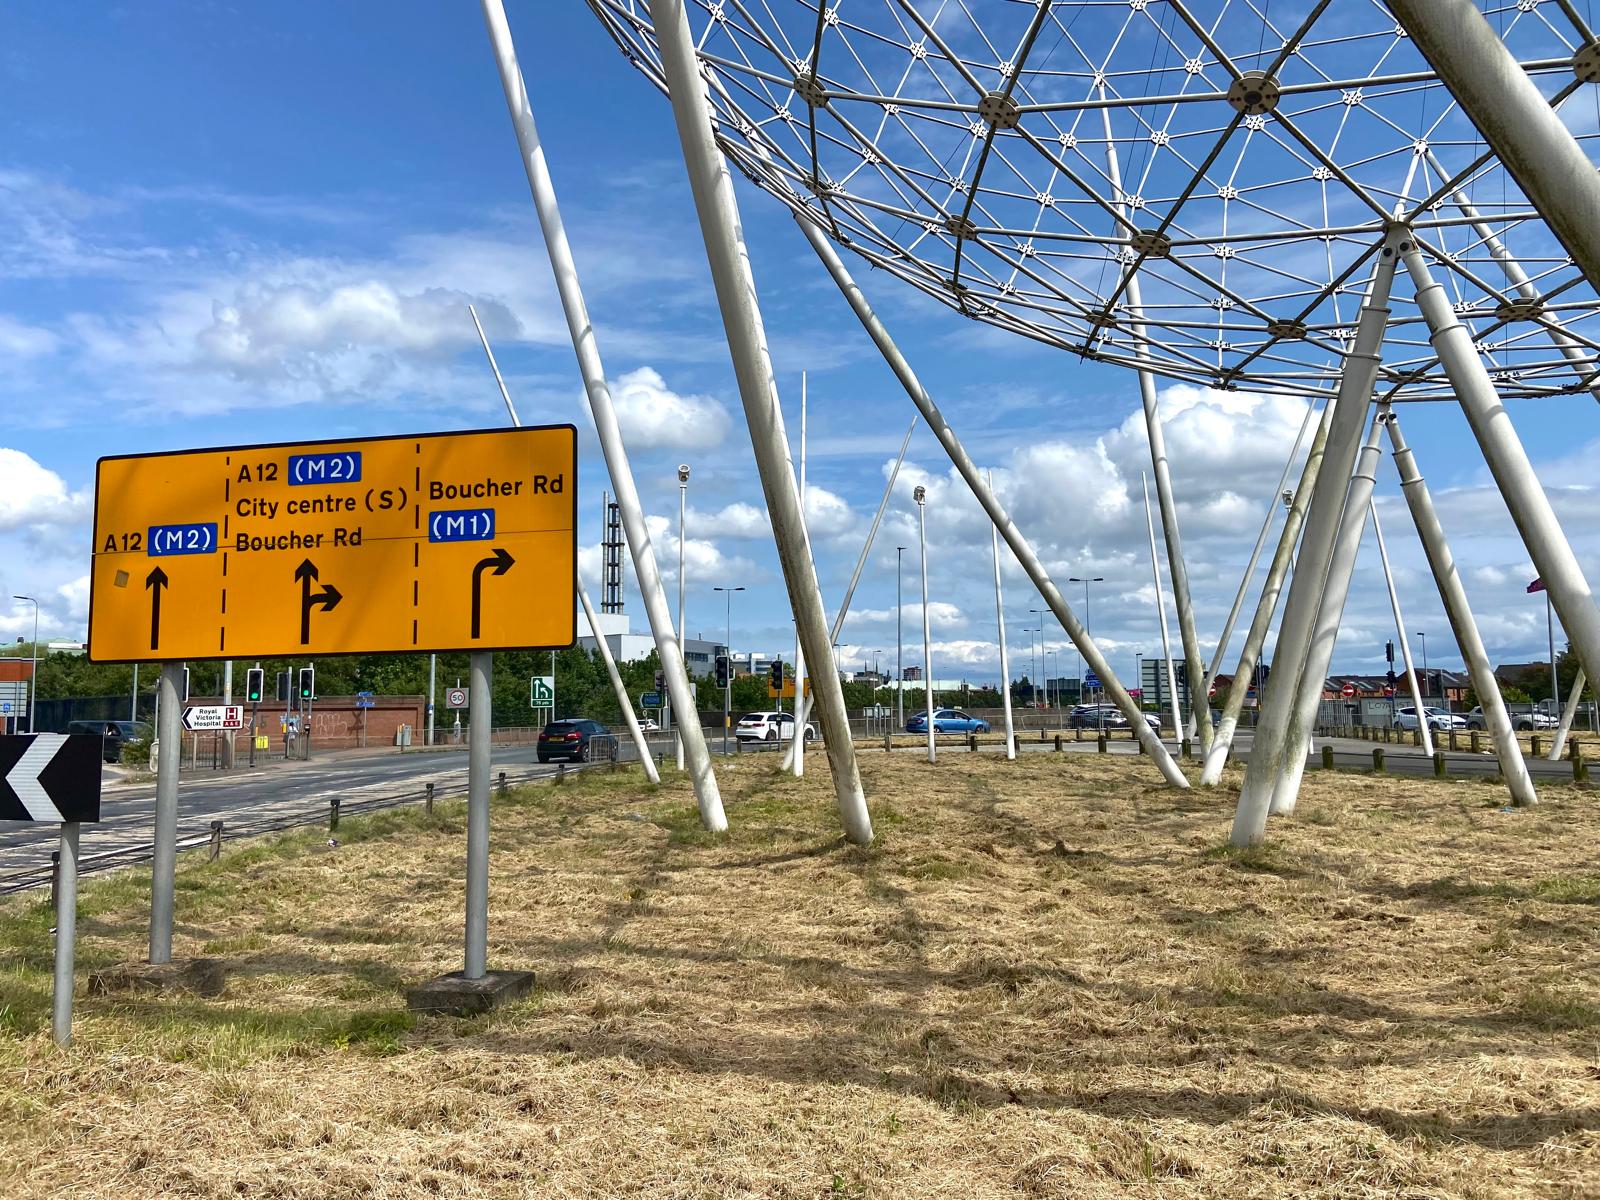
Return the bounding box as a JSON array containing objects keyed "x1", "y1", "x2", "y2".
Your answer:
[{"x1": 795, "y1": 214, "x2": 1189, "y2": 787}]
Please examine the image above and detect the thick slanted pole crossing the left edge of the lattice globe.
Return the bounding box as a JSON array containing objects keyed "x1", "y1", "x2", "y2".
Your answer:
[{"x1": 651, "y1": 0, "x2": 872, "y2": 845}]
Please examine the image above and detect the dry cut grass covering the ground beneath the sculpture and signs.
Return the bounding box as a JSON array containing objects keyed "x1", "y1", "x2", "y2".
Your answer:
[{"x1": 0, "y1": 754, "x2": 1600, "y2": 1200}]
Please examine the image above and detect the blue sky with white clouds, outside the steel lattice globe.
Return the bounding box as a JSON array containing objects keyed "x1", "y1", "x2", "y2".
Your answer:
[{"x1": 0, "y1": 3, "x2": 1600, "y2": 682}]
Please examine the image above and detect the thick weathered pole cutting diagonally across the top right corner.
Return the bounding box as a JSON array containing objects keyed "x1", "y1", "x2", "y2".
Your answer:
[{"x1": 1389, "y1": 0, "x2": 1600, "y2": 291}]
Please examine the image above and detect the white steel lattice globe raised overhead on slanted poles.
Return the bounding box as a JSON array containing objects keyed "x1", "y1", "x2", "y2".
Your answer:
[{"x1": 589, "y1": 0, "x2": 1600, "y2": 400}]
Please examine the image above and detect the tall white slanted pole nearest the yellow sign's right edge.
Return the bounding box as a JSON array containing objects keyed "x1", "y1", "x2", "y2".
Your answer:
[{"x1": 482, "y1": 0, "x2": 728, "y2": 834}]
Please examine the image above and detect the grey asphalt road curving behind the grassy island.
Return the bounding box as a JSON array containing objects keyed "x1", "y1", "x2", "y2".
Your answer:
[{"x1": 0, "y1": 730, "x2": 1573, "y2": 877}]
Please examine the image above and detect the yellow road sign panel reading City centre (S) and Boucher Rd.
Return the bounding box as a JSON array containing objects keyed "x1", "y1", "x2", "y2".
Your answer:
[{"x1": 88, "y1": 426, "x2": 578, "y2": 662}]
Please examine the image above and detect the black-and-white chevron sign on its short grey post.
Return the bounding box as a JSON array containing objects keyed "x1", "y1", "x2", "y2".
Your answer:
[{"x1": 0, "y1": 733, "x2": 102, "y2": 1046}]
